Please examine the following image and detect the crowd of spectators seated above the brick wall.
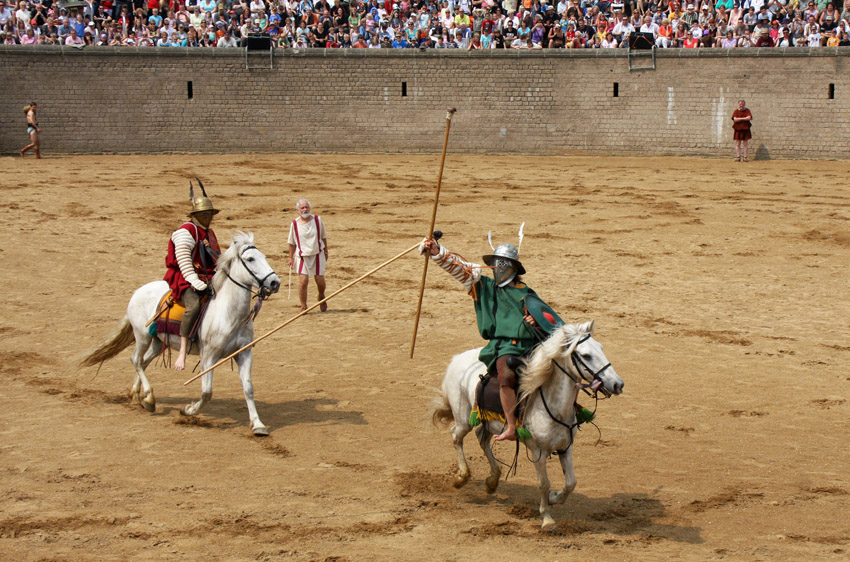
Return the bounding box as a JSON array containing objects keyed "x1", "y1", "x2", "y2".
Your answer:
[{"x1": 0, "y1": 0, "x2": 850, "y2": 50}]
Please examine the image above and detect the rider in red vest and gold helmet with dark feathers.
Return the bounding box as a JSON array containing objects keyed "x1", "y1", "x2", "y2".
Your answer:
[{"x1": 165, "y1": 178, "x2": 221, "y2": 371}]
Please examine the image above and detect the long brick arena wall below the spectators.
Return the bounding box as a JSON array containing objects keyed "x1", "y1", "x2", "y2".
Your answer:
[{"x1": 0, "y1": 46, "x2": 850, "y2": 158}]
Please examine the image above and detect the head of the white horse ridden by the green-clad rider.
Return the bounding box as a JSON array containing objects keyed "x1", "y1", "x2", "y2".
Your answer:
[{"x1": 561, "y1": 320, "x2": 625, "y2": 396}]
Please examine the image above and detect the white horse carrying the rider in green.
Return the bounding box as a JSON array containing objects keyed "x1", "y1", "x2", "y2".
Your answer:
[{"x1": 432, "y1": 322, "x2": 624, "y2": 528}]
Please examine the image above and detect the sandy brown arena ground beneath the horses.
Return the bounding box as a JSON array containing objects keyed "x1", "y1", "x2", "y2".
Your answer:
[{"x1": 0, "y1": 152, "x2": 850, "y2": 562}]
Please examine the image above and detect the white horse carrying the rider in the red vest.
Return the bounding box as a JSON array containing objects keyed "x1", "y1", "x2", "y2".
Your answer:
[{"x1": 80, "y1": 231, "x2": 280, "y2": 436}]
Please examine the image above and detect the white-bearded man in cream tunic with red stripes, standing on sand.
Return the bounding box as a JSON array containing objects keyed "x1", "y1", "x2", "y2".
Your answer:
[{"x1": 288, "y1": 199, "x2": 328, "y2": 312}]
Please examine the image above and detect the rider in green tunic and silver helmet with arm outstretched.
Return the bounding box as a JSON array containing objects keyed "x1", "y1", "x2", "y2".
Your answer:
[{"x1": 420, "y1": 227, "x2": 537, "y2": 441}]
